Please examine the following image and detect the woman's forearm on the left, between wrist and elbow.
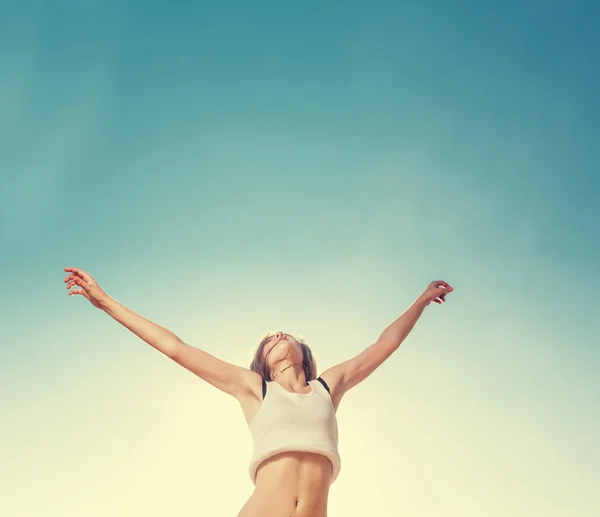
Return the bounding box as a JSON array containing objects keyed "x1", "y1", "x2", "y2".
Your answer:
[{"x1": 101, "y1": 298, "x2": 181, "y2": 357}]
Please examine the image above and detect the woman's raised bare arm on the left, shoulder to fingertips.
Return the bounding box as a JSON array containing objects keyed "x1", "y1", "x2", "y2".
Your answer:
[{"x1": 64, "y1": 268, "x2": 260, "y2": 399}]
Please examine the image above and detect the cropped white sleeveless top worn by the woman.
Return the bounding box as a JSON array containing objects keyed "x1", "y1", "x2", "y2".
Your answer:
[{"x1": 249, "y1": 374, "x2": 341, "y2": 484}]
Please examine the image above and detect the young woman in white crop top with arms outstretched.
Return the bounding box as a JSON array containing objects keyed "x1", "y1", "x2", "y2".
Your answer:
[{"x1": 64, "y1": 268, "x2": 453, "y2": 517}]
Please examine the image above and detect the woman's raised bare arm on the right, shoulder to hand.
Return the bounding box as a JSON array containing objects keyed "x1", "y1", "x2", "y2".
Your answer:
[{"x1": 321, "y1": 280, "x2": 454, "y2": 407}]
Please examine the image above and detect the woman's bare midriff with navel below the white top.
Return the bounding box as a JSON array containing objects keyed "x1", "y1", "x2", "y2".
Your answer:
[{"x1": 238, "y1": 452, "x2": 333, "y2": 517}]
